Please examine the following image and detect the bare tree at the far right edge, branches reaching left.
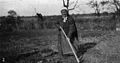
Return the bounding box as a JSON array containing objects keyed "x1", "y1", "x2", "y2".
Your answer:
[{"x1": 101, "y1": 0, "x2": 120, "y2": 29}]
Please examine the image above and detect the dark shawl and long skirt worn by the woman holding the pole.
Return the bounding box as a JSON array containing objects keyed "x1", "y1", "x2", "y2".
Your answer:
[{"x1": 59, "y1": 16, "x2": 78, "y2": 54}]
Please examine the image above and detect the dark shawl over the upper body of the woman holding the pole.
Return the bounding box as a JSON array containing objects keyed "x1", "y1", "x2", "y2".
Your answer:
[{"x1": 60, "y1": 16, "x2": 78, "y2": 39}]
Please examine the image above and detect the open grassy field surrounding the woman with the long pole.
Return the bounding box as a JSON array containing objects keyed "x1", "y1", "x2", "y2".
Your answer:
[{"x1": 0, "y1": 16, "x2": 120, "y2": 63}]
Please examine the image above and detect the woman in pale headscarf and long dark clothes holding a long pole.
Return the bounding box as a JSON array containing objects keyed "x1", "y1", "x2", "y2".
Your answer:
[{"x1": 58, "y1": 9, "x2": 78, "y2": 55}]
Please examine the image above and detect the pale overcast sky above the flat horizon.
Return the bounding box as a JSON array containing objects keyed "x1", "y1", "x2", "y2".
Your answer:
[{"x1": 0, "y1": 0, "x2": 93, "y2": 16}]
